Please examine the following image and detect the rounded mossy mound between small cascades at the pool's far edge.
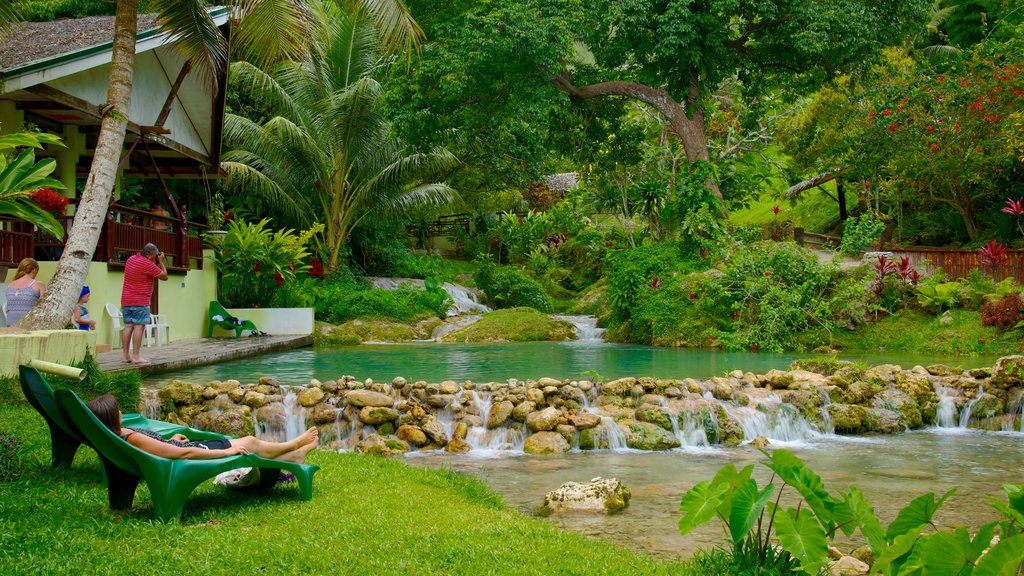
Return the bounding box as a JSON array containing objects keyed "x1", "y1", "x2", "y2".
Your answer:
[{"x1": 441, "y1": 307, "x2": 575, "y2": 342}]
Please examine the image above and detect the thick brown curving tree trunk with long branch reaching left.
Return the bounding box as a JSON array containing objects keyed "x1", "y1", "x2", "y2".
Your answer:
[{"x1": 551, "y1": 70, "x2": 729, "y2": 219}]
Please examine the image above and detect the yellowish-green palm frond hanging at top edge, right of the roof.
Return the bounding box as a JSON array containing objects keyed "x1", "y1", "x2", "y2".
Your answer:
[{"x1": 231, "y1": 0, "x2": 310, "y2": 68}]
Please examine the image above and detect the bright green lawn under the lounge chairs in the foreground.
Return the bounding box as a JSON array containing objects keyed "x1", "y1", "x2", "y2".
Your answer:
[{"x1": 0, "y1": 405, "x2": 689, "y2": 576}]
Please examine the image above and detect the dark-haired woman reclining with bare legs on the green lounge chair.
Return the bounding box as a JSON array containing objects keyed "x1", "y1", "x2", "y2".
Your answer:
[{"x1": 88, "y1": 394, "x2": 318, "y2": 464}]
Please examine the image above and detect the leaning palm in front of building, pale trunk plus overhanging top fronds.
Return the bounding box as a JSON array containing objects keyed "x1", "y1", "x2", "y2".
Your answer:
[{"x1": 19, "y1": 0, "x2": 422, "y2": 329}]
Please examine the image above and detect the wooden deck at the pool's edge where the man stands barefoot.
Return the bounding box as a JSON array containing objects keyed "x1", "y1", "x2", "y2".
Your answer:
[{"x1": 96, "y1": 335, "x2": 313, "y2": 374}]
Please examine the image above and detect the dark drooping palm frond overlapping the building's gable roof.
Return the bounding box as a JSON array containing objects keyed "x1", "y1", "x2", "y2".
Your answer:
[{"x1": 148, "y1": 0, "x2": 227, "y2": 85}]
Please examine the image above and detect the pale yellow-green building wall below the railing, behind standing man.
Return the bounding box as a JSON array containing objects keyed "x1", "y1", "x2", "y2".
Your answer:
[{"x1": 5, "y1": 250, "x2": 217, "y2": 351}]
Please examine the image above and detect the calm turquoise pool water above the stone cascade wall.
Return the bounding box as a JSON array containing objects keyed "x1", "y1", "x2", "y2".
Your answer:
[{"x1": 146, "y1": 341, "x2": 995, "y2": 385}]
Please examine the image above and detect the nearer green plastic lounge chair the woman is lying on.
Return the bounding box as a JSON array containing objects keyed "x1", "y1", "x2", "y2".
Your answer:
[{"x1": 53, "y1": 389, "x2": 319, "y2": 522}]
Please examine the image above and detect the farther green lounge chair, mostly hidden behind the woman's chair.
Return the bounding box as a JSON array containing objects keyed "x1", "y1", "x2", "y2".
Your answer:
[{"x1": 18, "y1": 364, "x2": 230, "y2": 467}]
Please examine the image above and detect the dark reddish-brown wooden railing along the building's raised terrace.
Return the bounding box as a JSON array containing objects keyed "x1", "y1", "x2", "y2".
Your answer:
[{"x1": 0, "y1": 199, "x2": 206, "y2": 272}]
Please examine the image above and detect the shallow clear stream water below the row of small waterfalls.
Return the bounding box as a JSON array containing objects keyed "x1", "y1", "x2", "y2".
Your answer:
[{"x1": 406, "y1": 430, "x2": 1024, "y2": 558}]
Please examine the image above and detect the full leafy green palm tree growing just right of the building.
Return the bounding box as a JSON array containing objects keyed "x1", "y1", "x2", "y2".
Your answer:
[{"x1": 221, "y1": 2, "x2": 457, "y2": 269}]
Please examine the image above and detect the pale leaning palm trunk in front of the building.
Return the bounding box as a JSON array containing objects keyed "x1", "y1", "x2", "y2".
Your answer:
[{"x1": 14, "y1": 0, "x2": 141, "y2": 329}]
